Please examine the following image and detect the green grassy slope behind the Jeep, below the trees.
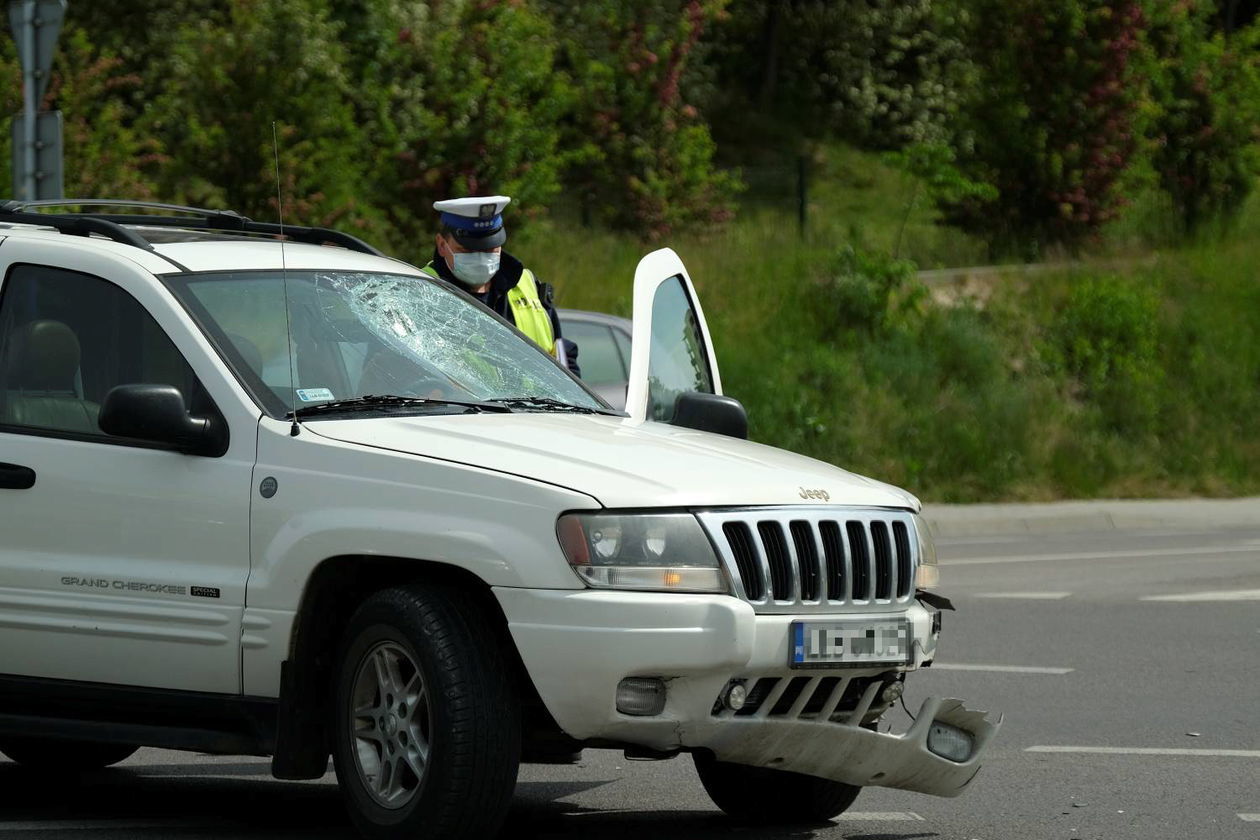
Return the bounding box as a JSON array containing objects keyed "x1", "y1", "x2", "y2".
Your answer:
[{"x1": 512, "y1": 147, "x2": 1260, "y2": 501}]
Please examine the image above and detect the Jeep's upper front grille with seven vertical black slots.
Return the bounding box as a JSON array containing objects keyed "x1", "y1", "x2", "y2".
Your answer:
[{"x1": 699, "y1": 508, "x2": 919, "y2": 612}]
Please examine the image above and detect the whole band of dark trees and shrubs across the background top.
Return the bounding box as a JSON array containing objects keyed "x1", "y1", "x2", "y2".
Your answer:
[{"x1": 0, "y1": 0, "x2": 1260, "y2": 258}]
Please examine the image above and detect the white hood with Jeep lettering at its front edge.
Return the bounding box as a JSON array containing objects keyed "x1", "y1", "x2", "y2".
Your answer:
[{"x1": 304, "y1": 413, "x2": 920, "y2": 510}]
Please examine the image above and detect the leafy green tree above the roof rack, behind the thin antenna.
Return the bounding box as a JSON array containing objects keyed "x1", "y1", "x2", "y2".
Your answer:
[{"x1": 144, "y1": 0, "x2": 367, "y2": 230}]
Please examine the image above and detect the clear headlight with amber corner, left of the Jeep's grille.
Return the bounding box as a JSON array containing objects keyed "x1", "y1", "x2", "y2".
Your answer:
[{"x1": 556, "y1": 514, "x2": 730, "y2": 593}]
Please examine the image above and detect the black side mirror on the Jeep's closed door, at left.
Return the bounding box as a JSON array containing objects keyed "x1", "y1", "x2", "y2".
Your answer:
[{"x1": 100, "y1": 385, "x2": 228, "y2": 457}]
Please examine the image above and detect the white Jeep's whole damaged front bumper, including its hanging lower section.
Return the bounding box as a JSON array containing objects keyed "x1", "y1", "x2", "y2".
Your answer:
[{"x1": 494, "y1": 588, "x2": 1000, "y2": 796}]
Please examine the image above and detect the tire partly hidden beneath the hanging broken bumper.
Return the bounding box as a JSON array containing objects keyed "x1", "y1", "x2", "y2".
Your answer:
[{"x1": 692, "y1": 753, "x2": 862, "y2": 825}]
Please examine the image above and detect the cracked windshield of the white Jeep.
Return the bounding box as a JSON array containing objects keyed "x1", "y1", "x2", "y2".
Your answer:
[{"x1": 171, "y1": 271, "x2": 605, "y2": 414}]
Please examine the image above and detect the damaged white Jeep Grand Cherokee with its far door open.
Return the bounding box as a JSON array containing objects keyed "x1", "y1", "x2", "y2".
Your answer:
[{"x1": 0, "y1": 201, "x2": 998, "y2": 837}]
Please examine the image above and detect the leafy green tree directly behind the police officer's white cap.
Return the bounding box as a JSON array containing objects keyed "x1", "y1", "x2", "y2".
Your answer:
[{"x1": 347, "y1": 0, "x2": 572, "y2": 258}]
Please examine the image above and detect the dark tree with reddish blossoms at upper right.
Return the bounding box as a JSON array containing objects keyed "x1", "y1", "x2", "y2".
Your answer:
[{"x1": 951, "y1": 0, "x2": 1145, "y2": 252}]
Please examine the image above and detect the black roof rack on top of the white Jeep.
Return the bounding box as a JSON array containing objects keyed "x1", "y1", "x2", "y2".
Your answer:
[{"x1": 0, "y1": 199, "x2": 386, "y2": 257}]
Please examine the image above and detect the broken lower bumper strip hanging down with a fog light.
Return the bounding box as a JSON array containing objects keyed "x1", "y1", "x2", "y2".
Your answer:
[{"x1": 683, "y1": 691, "x2": 1002, "y2": 796}]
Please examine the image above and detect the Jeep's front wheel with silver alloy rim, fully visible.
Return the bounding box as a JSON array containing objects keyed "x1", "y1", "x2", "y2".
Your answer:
[{"x1": 333, "y1": 586, "x2": 520, "y2": 840}]
